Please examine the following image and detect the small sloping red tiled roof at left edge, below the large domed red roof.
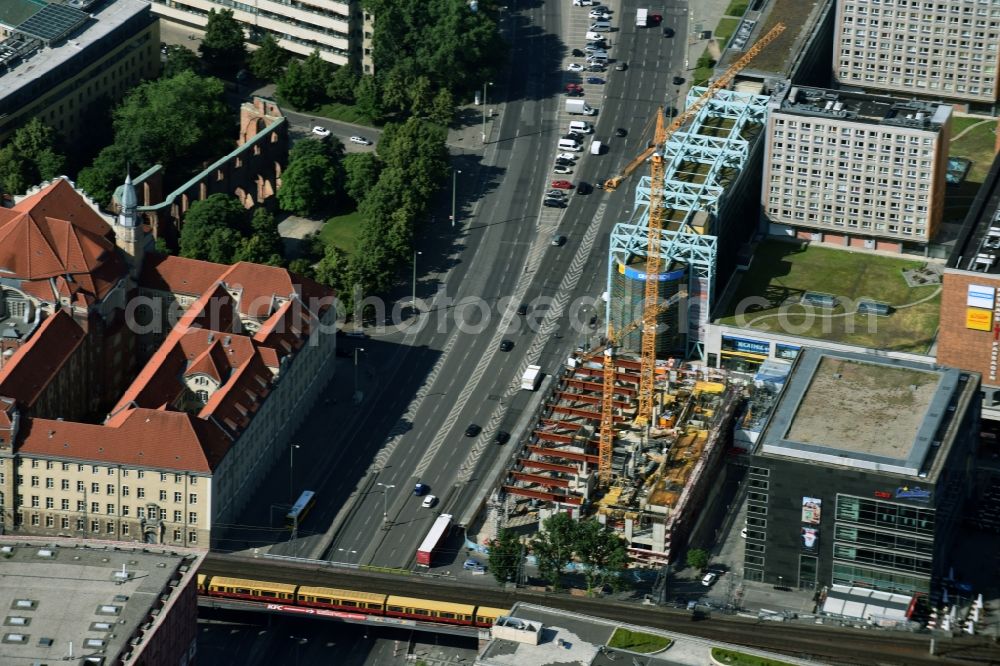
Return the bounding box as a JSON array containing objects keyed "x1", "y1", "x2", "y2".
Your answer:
[{"x1": 0, "y1": 310, "x2": 84, "y2": 408}]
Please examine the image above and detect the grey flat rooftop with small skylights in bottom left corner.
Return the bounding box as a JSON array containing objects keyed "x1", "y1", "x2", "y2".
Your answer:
[{"x1": 0, "y1": 537, "x2": 204, "y2": 664}]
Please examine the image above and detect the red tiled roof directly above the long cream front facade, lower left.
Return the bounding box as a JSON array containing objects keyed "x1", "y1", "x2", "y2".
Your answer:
[{"x1": 18, "y1": 409, "x2": 230, "y2": 473}]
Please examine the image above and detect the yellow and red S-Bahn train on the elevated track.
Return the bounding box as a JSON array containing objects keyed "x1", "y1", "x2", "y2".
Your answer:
[{"x1": 198, "y1": 574, "x2": 508, "y2": 627}]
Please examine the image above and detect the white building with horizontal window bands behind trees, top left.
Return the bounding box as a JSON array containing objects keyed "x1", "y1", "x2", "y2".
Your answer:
[{"x1": 151, "y1": 0, "x2": 371, "y2": 71}]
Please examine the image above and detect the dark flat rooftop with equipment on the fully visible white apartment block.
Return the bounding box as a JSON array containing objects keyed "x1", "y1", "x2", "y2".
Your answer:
[{"x1": 781, "y1": 86, "x2": 951, "y2": 132}]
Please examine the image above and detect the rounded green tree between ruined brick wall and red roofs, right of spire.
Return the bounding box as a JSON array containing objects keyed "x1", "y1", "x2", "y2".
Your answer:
[{"x1": 180, "y1": 194, "x2": 248, "y2": 264}]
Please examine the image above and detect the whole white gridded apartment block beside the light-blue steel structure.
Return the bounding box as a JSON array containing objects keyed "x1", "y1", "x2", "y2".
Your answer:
[{"x1": 761, "y1": 85, "x2": 952, "y2": 252}]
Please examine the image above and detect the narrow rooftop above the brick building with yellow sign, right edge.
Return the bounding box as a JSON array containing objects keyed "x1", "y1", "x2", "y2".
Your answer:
[{"x1": 948, "y1": 149, "x2": 1000, "y2": 275}]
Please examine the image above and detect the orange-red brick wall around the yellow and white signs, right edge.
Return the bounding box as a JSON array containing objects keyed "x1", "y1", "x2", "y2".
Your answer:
[{"x1": 937, "y1": 271, "x2": 1000, "y2": 385}]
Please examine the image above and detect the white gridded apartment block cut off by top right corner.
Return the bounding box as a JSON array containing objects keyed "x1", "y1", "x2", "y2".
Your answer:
[{"x1": 833, "y1": 0, "x2": 1000, "y2": 105}]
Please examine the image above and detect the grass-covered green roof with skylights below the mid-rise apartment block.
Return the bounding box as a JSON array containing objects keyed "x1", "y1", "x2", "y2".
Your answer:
[{"x1": 720, "y1": 240, "x2": 941, "y2": 353}]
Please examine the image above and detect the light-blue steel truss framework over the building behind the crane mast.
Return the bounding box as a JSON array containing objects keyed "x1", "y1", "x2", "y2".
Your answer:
[{"x1": 606, "y1": 87, "x2": 769, "y2": 358}]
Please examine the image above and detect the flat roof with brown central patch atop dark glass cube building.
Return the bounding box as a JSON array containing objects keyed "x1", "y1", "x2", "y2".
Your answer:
[{"x1": 758, "y1": 348, "x2": 967, "y2": 476}]
